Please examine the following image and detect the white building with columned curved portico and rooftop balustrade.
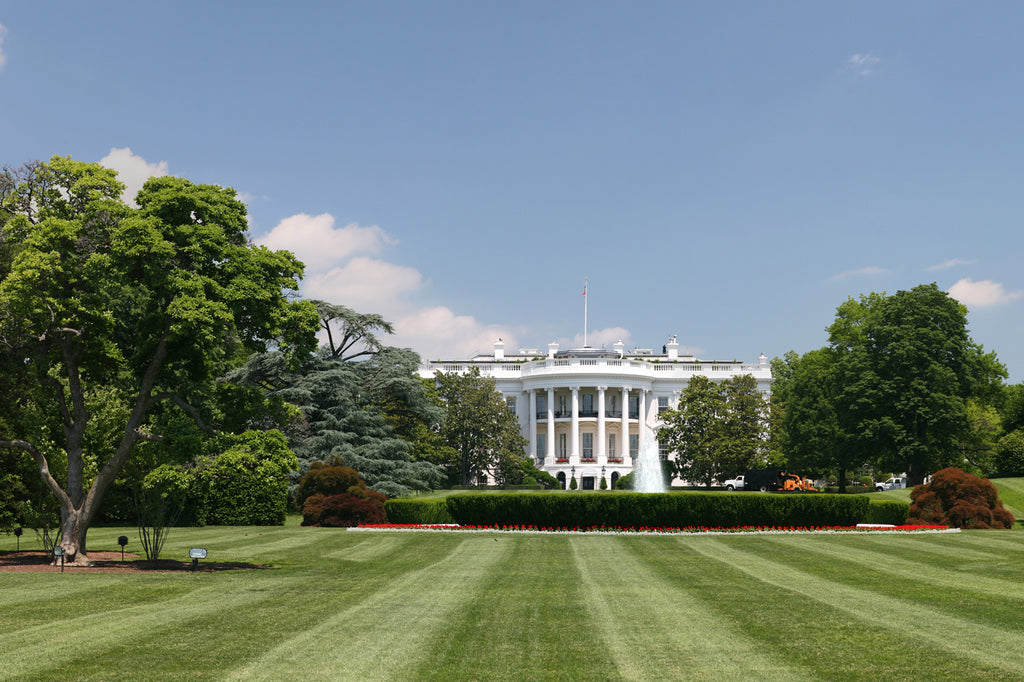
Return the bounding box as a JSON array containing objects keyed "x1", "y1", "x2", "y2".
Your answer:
[{"x1": 420, "y1": 337, "x2": 772, "y2": 489}]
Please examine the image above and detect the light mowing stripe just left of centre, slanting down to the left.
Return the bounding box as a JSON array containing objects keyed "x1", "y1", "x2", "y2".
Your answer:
[{"x1": 227, "y1": 534, "x2": 510, "y2": 680}]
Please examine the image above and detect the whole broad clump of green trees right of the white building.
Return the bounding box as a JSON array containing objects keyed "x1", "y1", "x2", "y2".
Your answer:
[{"x1": 772, "y1": 284, "x2": 1006, "y2": 489}]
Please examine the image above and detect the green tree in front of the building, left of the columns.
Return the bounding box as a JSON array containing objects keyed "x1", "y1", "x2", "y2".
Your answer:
[{"x1": 436, "y1": 368, "x2": 526, "y2": 485}]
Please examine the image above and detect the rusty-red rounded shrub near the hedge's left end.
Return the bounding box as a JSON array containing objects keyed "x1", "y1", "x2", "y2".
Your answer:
[{"x1": 296, "y1": 460, "x2": 387, "y2": 527}]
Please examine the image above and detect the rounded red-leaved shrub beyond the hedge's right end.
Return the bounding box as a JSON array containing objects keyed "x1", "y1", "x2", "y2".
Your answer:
[{"x1": 906, "y1": 467, "x2": 1015, "y2": 528}]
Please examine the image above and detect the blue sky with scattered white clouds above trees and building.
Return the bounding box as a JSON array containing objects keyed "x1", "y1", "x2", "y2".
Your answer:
[{"x1": 0, "y1": 0, "x2": 1024, "y2": 383}]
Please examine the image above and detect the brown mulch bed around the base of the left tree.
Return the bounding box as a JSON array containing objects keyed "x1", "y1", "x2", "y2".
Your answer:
[{"x1": 0, "y1": 550, "x2": 270, "y2": 573}]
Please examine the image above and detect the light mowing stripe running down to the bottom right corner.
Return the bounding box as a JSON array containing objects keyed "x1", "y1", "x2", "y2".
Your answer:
[{"x1": 692, "y1": 539, "x2": 1024, "y2": 678}]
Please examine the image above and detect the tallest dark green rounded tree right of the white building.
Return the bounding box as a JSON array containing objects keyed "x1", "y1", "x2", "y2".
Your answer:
[{"x1": 829, "y1": 284, "x2": 1006, "y2": 483}]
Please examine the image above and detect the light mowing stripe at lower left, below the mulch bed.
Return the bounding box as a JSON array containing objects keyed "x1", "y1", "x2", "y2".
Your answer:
[{"x1": 0, "y1": 577, "x2": 297, "y2": 678}]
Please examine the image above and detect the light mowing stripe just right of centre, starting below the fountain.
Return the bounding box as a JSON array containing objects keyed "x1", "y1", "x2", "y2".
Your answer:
[{"x1": 571, "y1": 537, "x2": 812, "y2": 680}]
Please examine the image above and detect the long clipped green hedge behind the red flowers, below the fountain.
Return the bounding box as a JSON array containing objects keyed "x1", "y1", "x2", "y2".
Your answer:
[{"x1": 444, "y1": 493, "x2": 868, "y2": 528}]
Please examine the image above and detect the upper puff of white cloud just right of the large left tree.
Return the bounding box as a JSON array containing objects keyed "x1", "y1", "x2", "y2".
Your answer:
[{"x1": 256, "y1": 213, "x2": 397, "y2": 273}]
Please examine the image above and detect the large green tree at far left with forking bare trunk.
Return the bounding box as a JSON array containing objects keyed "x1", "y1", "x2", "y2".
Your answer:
[{"x1": 0, "y1": 157, "x2": 316, "y2": 563}]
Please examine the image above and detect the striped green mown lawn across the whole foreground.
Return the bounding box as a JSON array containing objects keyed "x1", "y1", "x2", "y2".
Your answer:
[{"x1": 0, "y1": 525, "x2": 1024, "y2": 680}]
